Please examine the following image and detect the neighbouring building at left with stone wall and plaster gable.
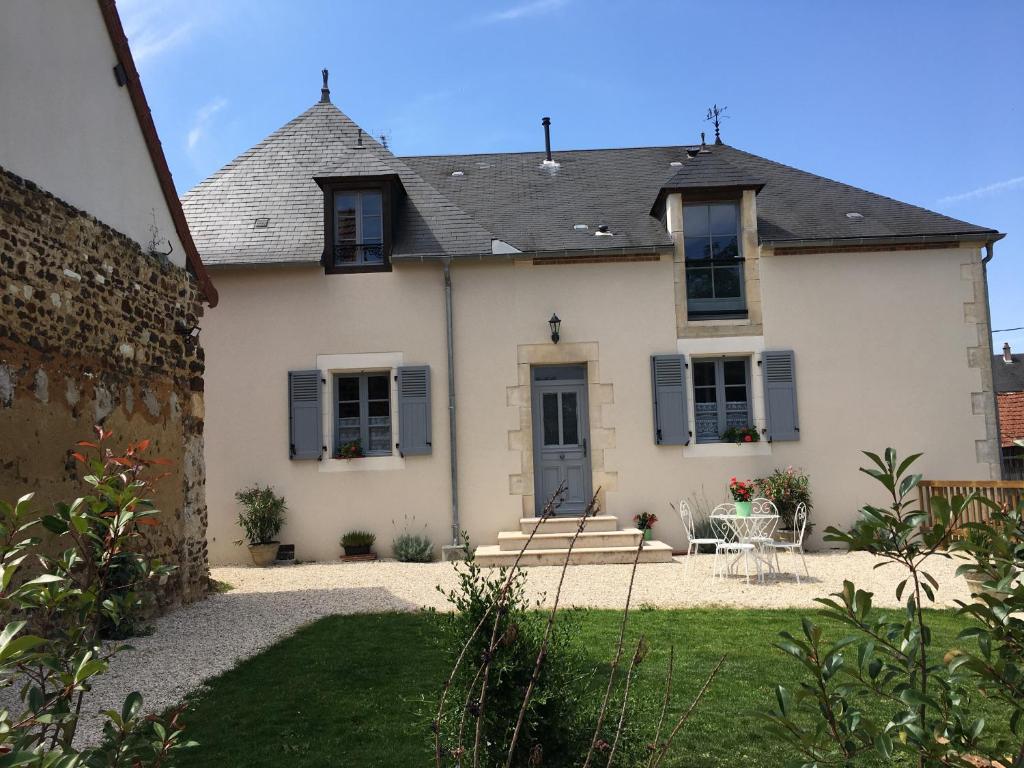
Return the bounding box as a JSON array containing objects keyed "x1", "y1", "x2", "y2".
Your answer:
[{"x1": 0, "y1": 0, "x2": 217, "y2": 602}]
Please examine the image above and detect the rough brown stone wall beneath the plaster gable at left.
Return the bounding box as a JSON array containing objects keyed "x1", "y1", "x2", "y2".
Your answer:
[{"x1": 0, "y1": 168, "x2": 208, "y2": 607}]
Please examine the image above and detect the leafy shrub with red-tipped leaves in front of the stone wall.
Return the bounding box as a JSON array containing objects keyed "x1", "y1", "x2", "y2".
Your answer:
[{"x1": 0, "y1": 427, "x2": 193, "y2": 768}]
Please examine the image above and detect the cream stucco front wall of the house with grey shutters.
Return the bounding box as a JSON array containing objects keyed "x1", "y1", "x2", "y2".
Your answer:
[{"x1": 197, "y1": 240, "x2": 991, "y2": 563}]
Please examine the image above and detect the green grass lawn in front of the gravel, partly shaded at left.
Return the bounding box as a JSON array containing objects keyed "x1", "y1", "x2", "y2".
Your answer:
[{"x1": 174, "y1": 609, "x2": 1006, "y2": 768}]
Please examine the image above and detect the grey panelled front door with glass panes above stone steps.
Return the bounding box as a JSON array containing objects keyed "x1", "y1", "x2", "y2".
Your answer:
[{"x1": 532, "y1": 366, "x2": 593, "y2": 515}]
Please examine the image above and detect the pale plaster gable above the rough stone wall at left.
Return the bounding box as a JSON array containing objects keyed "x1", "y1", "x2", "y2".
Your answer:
[{"x1": 0, "y1": 0, "x2": 185, "y2": 266}]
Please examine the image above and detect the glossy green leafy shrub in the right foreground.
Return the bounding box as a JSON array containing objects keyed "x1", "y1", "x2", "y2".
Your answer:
[{"x1": 765, "y1": 449, "x2": 1024, "y2": 768}]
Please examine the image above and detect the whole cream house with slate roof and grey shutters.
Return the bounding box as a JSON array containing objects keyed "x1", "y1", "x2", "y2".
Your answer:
[{"x1": 183, "y1": 71, "x2": 1002, "y2": 562}]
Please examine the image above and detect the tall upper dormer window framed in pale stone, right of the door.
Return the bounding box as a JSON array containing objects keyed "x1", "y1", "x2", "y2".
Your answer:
[{"x1": 683, "y1": 203, "x2": 746, "y2": 317}]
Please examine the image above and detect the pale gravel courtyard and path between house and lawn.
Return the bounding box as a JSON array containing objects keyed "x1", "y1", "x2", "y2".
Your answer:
[{"x1": 72, "y1": 553, "x2": 970, "y2": 739}]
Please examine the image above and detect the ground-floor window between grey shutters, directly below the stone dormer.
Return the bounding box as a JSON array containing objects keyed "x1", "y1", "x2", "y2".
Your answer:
[{"x1": 693, "y1": 357, "x2": 752, "y2": 442}]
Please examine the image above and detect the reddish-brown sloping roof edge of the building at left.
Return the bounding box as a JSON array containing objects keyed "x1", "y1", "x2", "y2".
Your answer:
[{"x1": 97, "y1": 0, "x2": 218, "y2": 306}]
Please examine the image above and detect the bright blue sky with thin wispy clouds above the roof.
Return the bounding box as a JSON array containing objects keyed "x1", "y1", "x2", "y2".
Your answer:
[{"x1": 119, "y1": 0, "x2": 1024, "y2": 351}]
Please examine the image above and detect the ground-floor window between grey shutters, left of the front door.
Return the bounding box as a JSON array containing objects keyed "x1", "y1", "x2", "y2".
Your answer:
[{"x1": 332, "y1": 373, "x2": 391, "y2": 456}]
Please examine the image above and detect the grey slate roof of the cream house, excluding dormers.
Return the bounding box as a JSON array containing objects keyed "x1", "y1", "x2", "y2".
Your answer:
[{"x1": 182, "y1": 102, "x2": 995, "y2": 265}]
